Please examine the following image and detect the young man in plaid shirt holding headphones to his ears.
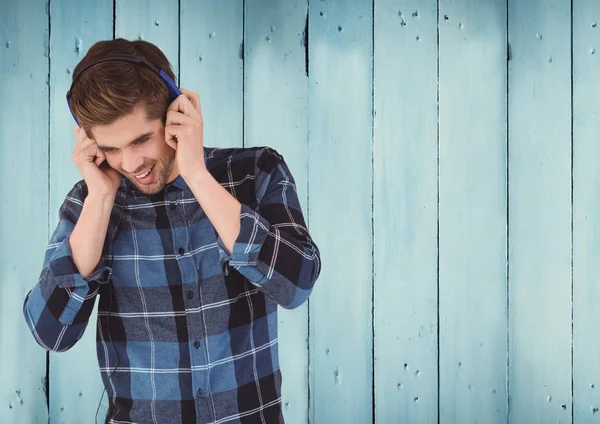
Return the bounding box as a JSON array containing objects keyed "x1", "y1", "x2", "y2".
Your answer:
[{"x1": 23, "y1": 39, "x2": 320, "y2": 424}]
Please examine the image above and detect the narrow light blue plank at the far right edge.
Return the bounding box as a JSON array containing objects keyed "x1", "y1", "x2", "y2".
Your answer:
[{"x1": 573, "y1": 0, "x2": 600, "y2": 424}]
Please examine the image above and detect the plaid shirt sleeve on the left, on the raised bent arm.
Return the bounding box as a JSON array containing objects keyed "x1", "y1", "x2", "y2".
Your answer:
[{"x1": 23, "y1": 182, "x2": 112, "y2": 352}]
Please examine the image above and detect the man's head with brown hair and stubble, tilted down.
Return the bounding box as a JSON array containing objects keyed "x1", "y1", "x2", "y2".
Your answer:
[{"x1": 71, "y1": 38, "x2": 178, "y2": 194}]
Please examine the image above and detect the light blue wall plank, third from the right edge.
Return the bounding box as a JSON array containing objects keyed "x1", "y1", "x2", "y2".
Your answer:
[{"x1": 439, "y1": 0, "x2": 508, "y2": 424}]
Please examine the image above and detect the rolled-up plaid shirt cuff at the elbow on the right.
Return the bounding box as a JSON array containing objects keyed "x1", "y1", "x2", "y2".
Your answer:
[{"x1": 217, "y1": 203, "x2": 271, "y2": 285}]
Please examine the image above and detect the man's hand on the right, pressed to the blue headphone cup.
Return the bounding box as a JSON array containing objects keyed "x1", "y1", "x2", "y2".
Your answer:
[{"x1": 165, "y1": 88, "x2": 205, "y2": 181}]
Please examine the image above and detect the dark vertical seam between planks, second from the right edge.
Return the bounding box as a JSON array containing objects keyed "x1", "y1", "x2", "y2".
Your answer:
[{"x1": 505, "y1": 0, "x2": 511, "y2": 424}]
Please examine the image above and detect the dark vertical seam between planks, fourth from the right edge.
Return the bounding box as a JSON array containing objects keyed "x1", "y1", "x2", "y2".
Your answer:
[{"x1": 371, "y1": 0, "x2": 376, "y2": 424}]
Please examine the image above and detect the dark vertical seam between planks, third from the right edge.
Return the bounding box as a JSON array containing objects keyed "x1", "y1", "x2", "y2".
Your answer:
[{"x1": 436, "y1": 0, "x2": 441, "y2": 424}]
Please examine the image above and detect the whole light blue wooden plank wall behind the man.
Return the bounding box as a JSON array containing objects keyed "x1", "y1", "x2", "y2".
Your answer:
[{"x1": 0, "y1": 0, "x2": 600, "y2": 424}]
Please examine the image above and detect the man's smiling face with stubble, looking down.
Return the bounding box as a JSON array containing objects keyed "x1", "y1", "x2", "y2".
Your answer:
[{"x1": 92, "y1": 102, "x2": 179, "y2": 194}]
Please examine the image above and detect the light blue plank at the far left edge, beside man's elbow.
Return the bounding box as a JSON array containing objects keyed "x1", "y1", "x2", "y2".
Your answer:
[{"x1": 0, "y1": 0, "x2": 48, "y2": 424}]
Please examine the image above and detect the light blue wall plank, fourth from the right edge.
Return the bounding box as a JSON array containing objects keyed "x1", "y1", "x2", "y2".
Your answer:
[{"x1": 376, "y1": 0, "x2": 438, "y2": 423}]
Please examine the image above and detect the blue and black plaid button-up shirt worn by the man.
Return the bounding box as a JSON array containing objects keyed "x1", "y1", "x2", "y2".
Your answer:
[{"x1": 23, "y1": 147, "x2": 320, "y2": 424}]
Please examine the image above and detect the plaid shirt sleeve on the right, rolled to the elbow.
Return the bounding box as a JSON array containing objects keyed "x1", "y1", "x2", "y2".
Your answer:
[{"x1": 218, "y1": 147, "x2": 321, "y2": 309}]
